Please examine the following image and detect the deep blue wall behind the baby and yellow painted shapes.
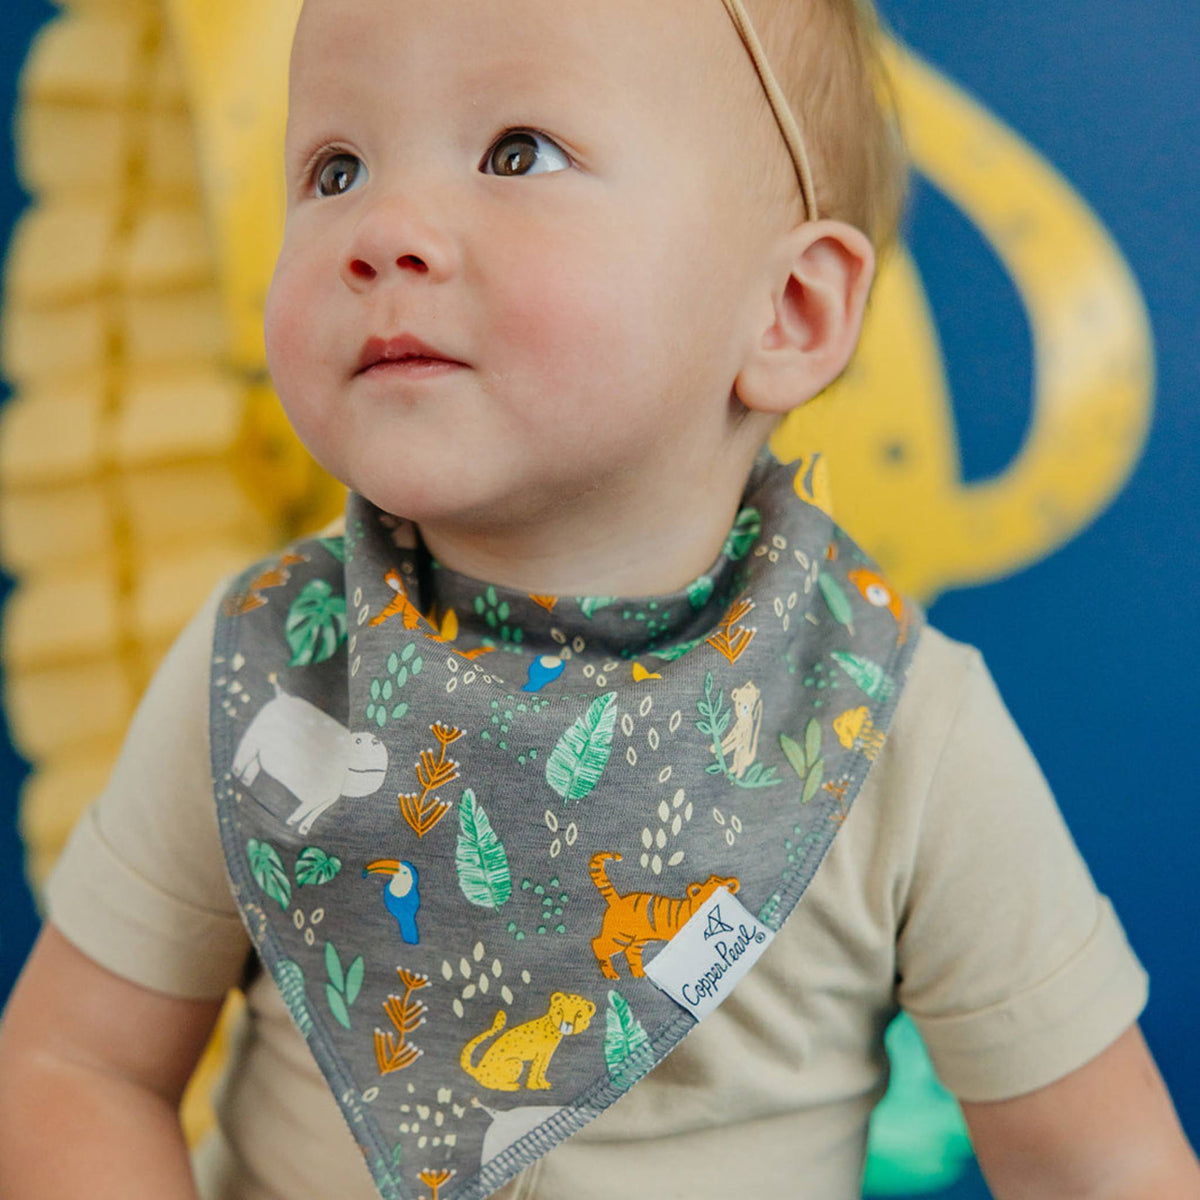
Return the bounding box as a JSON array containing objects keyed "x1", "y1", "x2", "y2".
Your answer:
[{"x1": 0, "y1": 0, "x2": 1200, "y2": 1200}]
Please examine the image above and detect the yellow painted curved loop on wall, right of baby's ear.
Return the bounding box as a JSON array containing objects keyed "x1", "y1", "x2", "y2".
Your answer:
[{"x1": 773, "y1": 47, "x2": 1154, "y2": 599}]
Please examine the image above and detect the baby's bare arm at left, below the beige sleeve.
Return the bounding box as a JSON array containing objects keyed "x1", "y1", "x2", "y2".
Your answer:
[{"x1": 0, "y1": 924, "x2": 222, "y2": 1200}]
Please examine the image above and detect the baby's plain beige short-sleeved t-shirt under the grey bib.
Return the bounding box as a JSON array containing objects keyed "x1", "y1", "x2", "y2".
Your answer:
[{"x1": 47, "y1": 583, "x2": 1147, "y2": 1200}]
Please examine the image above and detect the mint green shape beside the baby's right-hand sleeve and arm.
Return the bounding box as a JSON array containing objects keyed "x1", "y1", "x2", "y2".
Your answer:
[{"x1": 863, "y1": 1013, "x2": 972, "y2": 1196}]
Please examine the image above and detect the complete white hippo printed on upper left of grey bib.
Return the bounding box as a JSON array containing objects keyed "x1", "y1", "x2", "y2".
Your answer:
[{"x1": 233, "y1": 680, "x2": 388, "y2": 834}]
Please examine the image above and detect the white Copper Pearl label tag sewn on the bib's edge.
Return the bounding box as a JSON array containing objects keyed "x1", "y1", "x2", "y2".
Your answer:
[{"x1": 646, "y1": 888, "x2": 775, "y2": 1021}]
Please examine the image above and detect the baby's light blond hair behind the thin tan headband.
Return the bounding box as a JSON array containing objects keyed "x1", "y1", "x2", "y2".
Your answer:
[{"x1": 744, "y1": 0, "x2": 908, "y2": 251}]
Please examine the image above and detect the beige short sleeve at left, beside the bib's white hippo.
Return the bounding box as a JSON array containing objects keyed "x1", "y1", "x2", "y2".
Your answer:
[{"x1": 46, "y1": 584, "x2": 251, "y2": 998}]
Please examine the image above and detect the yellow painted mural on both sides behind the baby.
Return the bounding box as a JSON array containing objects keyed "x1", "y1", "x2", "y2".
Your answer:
[{"x1": 0, "y1": 0, "x2": 1153, "y2": 1139}]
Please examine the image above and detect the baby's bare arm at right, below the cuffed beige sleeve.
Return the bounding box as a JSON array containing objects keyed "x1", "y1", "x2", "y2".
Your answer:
[{"x1": 962, "y1": 1025, "x2": 1200, "y2": 1200}]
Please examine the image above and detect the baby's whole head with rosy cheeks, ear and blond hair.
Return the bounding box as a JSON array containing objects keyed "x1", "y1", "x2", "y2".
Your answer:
[{"x1": 266, "y1": 0, "x2": 899, "y2": 590}]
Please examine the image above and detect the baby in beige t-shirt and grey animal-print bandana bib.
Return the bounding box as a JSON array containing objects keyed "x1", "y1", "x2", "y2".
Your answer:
[{"x1": 0, "y1": 0, "x2": 1200, "y2": 1200}]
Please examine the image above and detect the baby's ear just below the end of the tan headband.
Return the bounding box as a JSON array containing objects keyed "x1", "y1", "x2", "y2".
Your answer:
[{"x1": 734, "y1": 221, "x2": 875, "y2": 415}]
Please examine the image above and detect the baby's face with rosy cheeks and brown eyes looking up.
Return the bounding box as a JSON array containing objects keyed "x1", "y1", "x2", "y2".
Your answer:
[{"x1": 266, "y1": 0, "x2": 766, "y2": 529}]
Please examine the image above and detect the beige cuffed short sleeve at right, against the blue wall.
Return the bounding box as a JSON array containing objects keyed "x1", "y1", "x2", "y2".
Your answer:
[{"x1": 896, "y1": 652, "x2": 1148, "y2": 1100}]
